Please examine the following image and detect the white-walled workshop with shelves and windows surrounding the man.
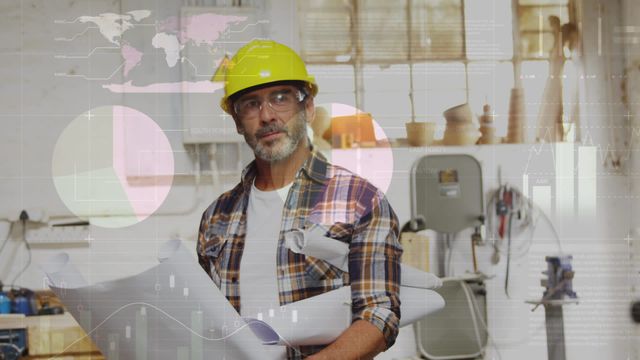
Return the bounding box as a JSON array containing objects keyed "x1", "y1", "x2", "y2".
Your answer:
[{"x1": 0, "y1": 0, "x2": 640, "y2": 360}]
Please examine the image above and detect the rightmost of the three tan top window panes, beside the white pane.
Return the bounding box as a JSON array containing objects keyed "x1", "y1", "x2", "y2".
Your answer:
[{"x1": 411, "y1": 0, "x2": 464, "y2": 60}]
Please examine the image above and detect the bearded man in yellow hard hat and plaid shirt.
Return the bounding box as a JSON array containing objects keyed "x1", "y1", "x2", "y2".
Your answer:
[{"x1": 197, "y1": 40, "x2": 402, "y2": 359}]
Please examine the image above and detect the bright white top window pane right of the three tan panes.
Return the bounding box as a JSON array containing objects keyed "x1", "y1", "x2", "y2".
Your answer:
[{"x1": 465, "y1": 0, "x2": 513, "y2": 60}]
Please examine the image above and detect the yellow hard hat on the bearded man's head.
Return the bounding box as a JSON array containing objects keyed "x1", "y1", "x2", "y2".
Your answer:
[{"x1": 211, "y1": 40, "x2": 318, "y2": 113}]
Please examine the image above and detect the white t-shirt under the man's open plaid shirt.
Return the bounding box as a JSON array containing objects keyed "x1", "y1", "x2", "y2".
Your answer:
[{"x1": 240, "y1": 184, "x2": 291, "y2": 319}]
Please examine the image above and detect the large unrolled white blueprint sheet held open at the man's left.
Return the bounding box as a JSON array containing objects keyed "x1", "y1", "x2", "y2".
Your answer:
[{"x1": 47, "y1": 240, "x2": 282, "y2": 360}]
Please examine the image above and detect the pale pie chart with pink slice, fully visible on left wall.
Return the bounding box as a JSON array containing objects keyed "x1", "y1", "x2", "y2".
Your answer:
[{"x1": 51, "y1": 106, "x2": 174, "y2": 228}]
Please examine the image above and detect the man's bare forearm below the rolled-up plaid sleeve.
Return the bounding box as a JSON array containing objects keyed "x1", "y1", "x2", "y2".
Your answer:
[{"x1": 307, "y1": 320, "x2": 386, "y2": 360}]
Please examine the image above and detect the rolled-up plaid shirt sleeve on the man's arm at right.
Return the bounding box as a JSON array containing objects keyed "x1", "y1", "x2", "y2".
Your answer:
[{"x1": 349, "y1": 190, "x2": 402, "y2": 349}]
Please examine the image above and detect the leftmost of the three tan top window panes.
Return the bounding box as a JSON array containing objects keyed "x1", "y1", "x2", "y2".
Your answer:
[{"x1": 299, "y1": 0, "x2": 352, "y2": 62}]
